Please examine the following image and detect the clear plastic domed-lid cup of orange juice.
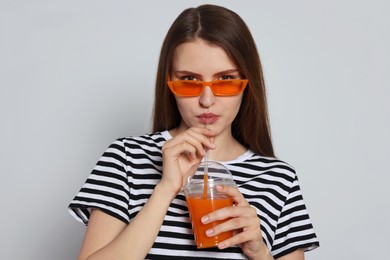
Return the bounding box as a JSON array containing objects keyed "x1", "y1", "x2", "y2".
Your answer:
[{"x1": 183, "y1": 161, "x2": 235, "y2": 248}]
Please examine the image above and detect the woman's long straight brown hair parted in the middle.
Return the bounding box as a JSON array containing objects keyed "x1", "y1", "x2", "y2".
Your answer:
[{"x1": 153, "y1": 5, "x2": 274, "y2": 157}]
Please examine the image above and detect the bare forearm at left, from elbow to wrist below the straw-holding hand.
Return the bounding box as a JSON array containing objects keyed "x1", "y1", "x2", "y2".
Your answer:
[{"x1": 87, "y1": 185, "x2": 173, "y2": 260}]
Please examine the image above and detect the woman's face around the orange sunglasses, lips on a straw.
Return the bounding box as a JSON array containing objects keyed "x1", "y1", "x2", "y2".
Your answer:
[{"x1": 170, "y1": 39, "x2": 243, "y2": 138}]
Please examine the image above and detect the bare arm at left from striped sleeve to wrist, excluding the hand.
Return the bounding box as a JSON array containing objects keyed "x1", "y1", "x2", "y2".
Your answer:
[{"x1": 79, "y1": 185, "x2": 174, "y2": 260}]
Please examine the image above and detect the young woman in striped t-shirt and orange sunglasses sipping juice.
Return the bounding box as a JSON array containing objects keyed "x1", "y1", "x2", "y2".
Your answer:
[{"x1": 69, "y1": 5, "x2": 319, "y2": 260}]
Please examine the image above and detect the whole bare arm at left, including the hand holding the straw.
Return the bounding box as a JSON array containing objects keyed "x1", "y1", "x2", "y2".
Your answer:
[{"x1": 79, "y1": 128, "x2": 215, "y2": 260}]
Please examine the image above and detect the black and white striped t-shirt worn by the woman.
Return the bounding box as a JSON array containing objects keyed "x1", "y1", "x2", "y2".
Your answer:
[{"x1": 69, "y1": 131, "x2": 319, "y2": 259}]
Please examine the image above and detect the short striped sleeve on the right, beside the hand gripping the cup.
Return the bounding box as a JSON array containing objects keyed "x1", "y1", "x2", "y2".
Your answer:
[{"x1": 272, "y1": 175, "x2": 319, "y2": 258}]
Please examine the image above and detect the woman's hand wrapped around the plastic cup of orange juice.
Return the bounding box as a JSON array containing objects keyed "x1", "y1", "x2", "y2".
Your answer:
[{"x1": 202, "y1": 186, "x2": 273, "y2": 259}]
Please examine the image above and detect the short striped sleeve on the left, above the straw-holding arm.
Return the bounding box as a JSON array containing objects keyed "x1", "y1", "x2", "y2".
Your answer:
[{"x1": 68, "y1": 139, "x2": 130, "y2": 225}]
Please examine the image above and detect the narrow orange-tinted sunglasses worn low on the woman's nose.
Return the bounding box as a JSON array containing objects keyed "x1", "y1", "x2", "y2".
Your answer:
[{"x1": 167, "y1": 76, "x2": 248, "y2": 97}]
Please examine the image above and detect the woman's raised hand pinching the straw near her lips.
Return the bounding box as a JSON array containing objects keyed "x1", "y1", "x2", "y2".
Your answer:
[{"x1": 160, "y1": 127, "x2": 215, "y2": 196}]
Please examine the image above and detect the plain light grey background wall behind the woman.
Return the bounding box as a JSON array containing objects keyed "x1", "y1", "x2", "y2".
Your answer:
[{"x1": 0, "y1": 0, "x2": 390, "y2": 260}]
